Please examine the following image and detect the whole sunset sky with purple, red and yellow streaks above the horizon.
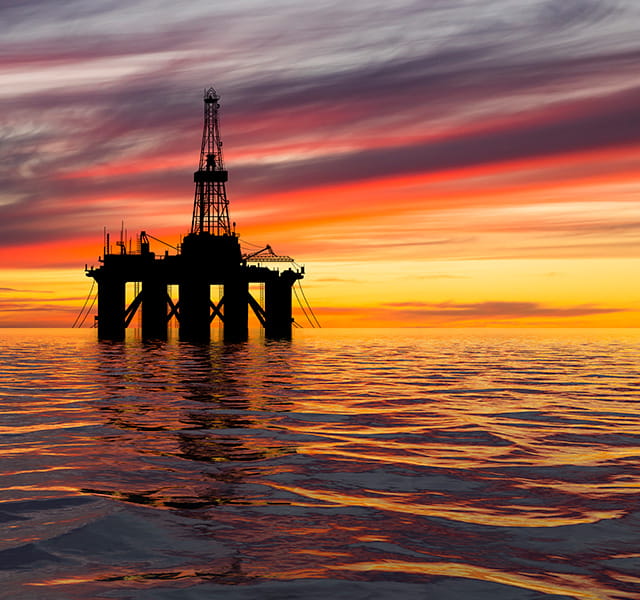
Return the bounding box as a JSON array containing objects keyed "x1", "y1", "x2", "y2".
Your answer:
[{"x1": 0, "y1": 0, "x2": 640, "y2": 327}]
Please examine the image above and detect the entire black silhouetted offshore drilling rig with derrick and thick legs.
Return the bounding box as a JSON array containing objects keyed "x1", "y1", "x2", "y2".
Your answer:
[{"x1": 86, "y1": 87, "x2": 304, "y2": 341}]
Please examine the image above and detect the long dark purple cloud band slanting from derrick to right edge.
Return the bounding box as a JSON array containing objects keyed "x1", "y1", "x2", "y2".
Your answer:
[{"x1": 230, "y1": 87, "x2": 640, "y2": 192}]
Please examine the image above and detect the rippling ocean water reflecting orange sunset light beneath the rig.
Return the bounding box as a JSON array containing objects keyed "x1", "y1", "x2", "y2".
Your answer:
[{"x1": 0, "y1": 329, "x2": 640, "y2": 600}]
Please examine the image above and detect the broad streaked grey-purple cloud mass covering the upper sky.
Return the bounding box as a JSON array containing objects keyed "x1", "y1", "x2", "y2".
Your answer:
[{"x1": 0, "y1": 0, "x2": 640, "y2": 253}]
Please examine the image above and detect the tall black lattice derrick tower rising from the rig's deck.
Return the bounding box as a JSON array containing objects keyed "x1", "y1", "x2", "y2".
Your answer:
[{"x1": 191, "y1": 87, "x2": 232, "y2": 236}]
